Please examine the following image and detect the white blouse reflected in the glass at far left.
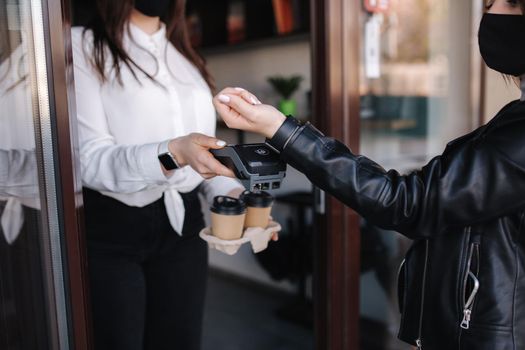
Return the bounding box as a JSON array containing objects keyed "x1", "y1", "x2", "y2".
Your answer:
[{"x1": 0, "y1": 39, "x2": 40, "y2": 244}]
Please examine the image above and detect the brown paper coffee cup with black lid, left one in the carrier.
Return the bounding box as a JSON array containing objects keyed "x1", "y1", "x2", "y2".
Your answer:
[{"x1": 210, "y1": 196, "x2": 246, "y2": 240}]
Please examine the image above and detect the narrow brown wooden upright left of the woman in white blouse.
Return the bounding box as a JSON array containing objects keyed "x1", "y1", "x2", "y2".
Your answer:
[{"x1": 42, "y1": 0, "x2": 92, "y2": 350}]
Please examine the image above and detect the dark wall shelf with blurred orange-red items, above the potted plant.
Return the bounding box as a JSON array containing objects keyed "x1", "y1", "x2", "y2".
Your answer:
[{"x1": 186, "y1": 0, "x2": 311, "y2": 56}]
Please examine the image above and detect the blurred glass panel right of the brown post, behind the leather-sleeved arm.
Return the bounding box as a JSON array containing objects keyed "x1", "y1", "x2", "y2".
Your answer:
[{"x1": 360, "y1": 0, "x2": 481, "y2": 349}]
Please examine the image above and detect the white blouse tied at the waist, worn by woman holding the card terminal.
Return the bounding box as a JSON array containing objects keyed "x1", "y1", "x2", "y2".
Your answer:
[{"x1": 72, "y1": 24, "x2": 241, "y2": 234}]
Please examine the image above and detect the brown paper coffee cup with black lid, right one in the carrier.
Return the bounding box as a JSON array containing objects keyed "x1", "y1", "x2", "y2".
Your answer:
[{"x1": 241, "y1": 191, "x2": 273, "y2": 228}]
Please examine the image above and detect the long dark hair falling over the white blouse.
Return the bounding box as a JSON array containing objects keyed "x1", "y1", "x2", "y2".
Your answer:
[{"x1": 84, "y1": 0, "x2": 215, "y2": 90}]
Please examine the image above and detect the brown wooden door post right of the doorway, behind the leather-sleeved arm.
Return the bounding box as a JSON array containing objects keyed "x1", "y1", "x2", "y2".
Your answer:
[{"x1": 311, "y1": 0, "x2": 361, "y2": 350}]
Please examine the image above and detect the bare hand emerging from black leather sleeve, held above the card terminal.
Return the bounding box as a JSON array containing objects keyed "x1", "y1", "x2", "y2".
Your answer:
[{"x1": 213, "y1": 88, "x2": 286, "y2": 138}]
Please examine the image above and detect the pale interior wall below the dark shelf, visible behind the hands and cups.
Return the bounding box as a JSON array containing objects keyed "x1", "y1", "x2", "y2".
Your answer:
[{"x1": 206, "y1": 40, "x2": 311, "y2": 291}]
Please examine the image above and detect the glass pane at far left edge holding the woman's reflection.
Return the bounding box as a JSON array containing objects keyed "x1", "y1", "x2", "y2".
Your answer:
[{"x1": 0, "y1": 0, "x2": 49, "y2": 350}]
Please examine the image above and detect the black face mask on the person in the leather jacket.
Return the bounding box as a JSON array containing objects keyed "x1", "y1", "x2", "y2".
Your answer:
[{"x1": 478, "y1": 13, "x2": 525, "y2": 76}]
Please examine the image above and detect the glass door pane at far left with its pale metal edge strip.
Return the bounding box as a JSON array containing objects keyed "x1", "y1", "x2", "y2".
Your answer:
[{"x1": 0, "y1": 0, "x2": 67, "y2": 350}]
